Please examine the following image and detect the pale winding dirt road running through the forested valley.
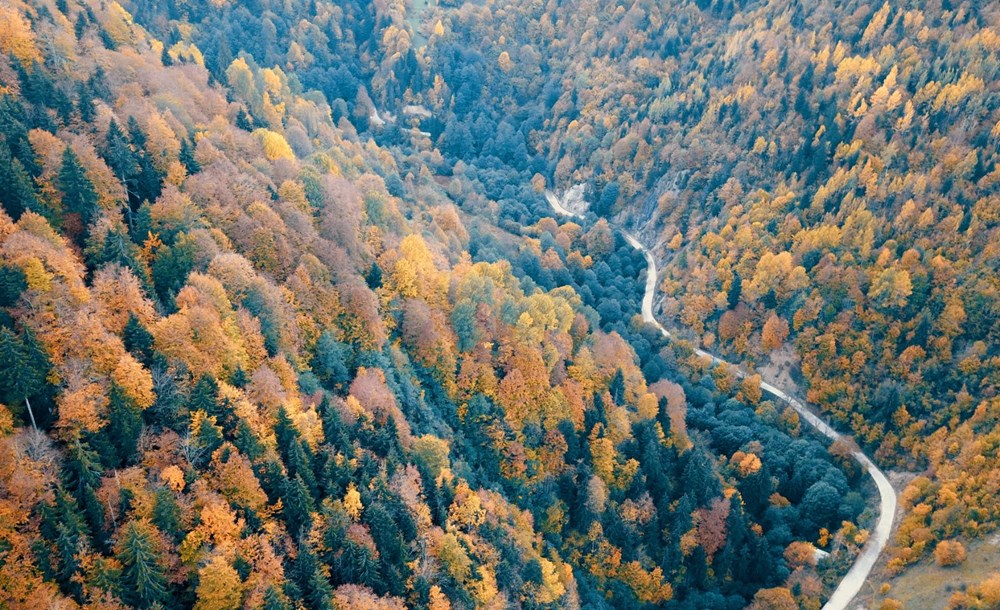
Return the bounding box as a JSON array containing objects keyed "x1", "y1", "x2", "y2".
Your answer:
[{"x1": 545, "y1": 191, "x2": 896, "y2": 610}]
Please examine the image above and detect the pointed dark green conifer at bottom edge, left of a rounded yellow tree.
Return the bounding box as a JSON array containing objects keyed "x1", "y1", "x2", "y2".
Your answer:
[{"x1": 117, "y1": 521, "x2": 167, "y2": 608}]
